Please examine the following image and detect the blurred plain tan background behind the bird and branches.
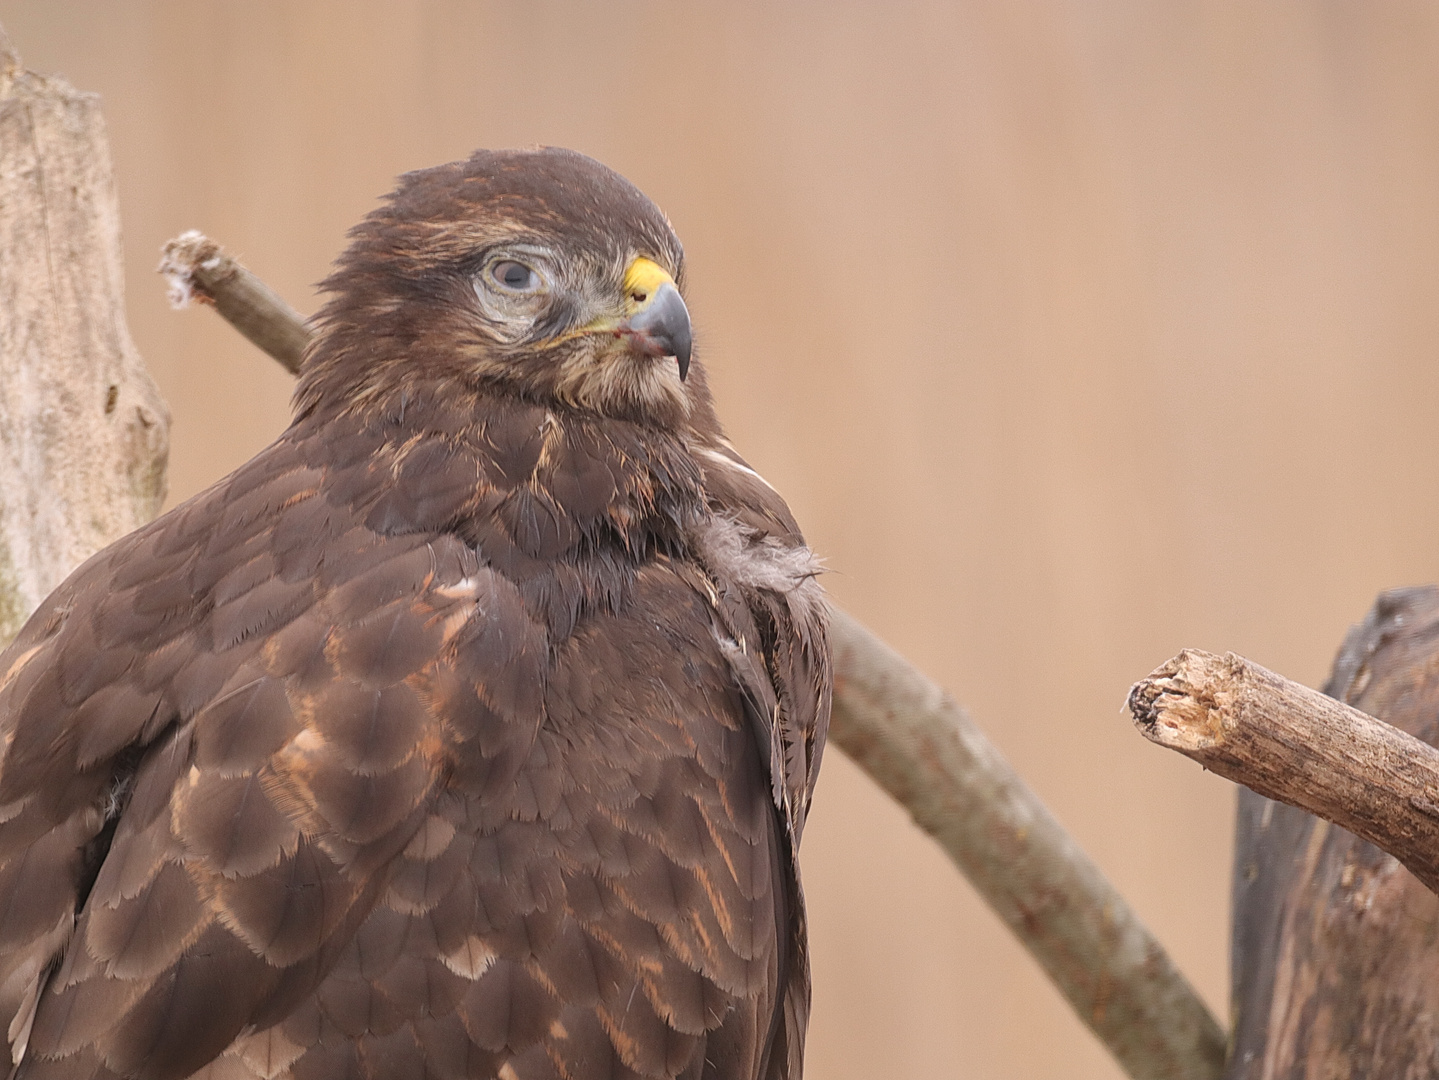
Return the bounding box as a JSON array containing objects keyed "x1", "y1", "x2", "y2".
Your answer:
[{"x1": 0, "y1": 0, "x2": 1439, "y2": 1080}]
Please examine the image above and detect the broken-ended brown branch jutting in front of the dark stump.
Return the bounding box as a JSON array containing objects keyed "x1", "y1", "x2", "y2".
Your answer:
[{"x1": 1130, "y1": 650, "x2": 1439, "y2": 892}]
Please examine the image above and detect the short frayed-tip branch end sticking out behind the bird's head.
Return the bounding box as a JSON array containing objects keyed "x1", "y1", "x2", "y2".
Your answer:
[{"x1": 160, "y1": 229, "x2": 309, "y2": 375}]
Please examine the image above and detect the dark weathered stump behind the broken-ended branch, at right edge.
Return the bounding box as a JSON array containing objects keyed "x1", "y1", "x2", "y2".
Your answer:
[{"x1": 1226, "y1": 587, "x2": 1439, "y2": 1080}]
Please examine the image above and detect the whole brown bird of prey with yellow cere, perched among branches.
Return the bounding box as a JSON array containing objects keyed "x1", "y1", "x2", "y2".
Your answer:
[{"x1": 0, "y1": 150, "x2": 829, "y2": 1080}]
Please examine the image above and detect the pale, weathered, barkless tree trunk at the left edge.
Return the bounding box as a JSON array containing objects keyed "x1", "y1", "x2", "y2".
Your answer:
[{"x1": 0, "y1": 30, "x2": 170, "y2": 643}]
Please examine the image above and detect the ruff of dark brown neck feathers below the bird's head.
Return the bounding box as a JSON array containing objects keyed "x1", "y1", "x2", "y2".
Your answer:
[{"x1": 296, "y1": 387, "x2": 705, "y2": 637}]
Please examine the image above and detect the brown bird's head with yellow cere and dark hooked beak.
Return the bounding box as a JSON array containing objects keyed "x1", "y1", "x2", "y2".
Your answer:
[{"x1": 299, "y1": 148, "x2": 702, "y2": 427}]
